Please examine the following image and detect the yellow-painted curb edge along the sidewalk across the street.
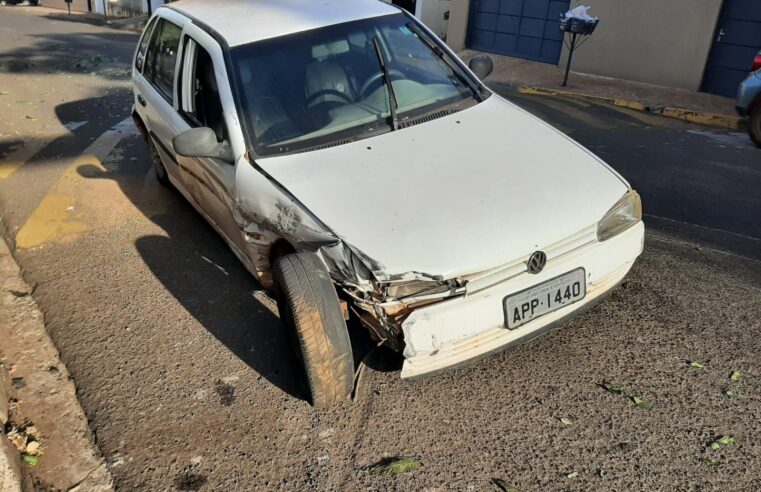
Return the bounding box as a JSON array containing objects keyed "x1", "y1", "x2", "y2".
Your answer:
[{"x1": 518, "y1": 86, "x2": 746, "y2": 130}]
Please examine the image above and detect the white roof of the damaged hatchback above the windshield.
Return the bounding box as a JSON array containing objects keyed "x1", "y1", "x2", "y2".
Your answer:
[{"x1": 160, "y1": 0, "x2": 399, "y2": 46}]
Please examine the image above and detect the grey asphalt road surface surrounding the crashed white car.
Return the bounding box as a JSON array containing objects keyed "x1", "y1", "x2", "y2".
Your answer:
[{"x1": 0, "y1": 7, "x2": 761, "y2": 490}]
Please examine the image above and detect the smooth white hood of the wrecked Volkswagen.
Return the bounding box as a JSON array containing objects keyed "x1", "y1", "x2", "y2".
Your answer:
[{"x1": 257, "y1": 95, "x2": 628, "y2": 279}]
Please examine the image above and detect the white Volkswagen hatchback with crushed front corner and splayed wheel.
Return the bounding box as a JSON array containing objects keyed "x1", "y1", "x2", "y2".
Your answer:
[{"x1": 132, "y1": 0, "x2": 644, "y2": 405}]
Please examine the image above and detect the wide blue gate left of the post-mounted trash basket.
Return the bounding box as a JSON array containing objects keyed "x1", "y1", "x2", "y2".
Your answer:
[{"x1": 468, "y1": 0, "x2": 570, "y2": 64}]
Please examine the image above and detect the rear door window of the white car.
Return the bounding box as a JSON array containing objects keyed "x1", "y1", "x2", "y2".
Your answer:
[{"x1": 143, "y1": 19, "x2": 182, "y2": 102}]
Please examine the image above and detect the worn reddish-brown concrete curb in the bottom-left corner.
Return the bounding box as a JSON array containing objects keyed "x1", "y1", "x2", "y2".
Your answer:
[{"x1": 0, "y1": 237, "x2": 114, "y2": 492}]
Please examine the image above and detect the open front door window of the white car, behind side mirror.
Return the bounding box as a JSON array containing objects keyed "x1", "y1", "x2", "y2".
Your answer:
[{"x1": 182, "y1": 38, "x2": 227, "y2": 142}]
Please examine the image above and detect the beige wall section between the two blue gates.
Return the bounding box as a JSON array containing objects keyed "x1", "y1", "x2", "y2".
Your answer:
[{"x1": 560, "y1": 0, "x2": 722, "y2": 90}]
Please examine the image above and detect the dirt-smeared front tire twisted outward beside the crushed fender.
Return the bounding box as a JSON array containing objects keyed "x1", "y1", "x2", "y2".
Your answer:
[{"x1": 273, "y1": 253, "x2": 354, "y2": 407}]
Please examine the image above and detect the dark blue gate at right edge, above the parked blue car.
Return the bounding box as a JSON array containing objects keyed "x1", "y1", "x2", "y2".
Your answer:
[{"x1": 702, "y1": 0, "x2": 761, "y2": 97}]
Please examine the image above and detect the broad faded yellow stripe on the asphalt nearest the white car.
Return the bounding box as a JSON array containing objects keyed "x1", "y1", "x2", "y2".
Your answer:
[{"x1": 16, "y1": 118, "x2": 137, "y2": 249}]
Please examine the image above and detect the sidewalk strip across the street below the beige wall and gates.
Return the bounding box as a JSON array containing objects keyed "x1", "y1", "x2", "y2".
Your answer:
[{"x1": 459, "y1": 50, "x2": 743, "y2": 129}]
